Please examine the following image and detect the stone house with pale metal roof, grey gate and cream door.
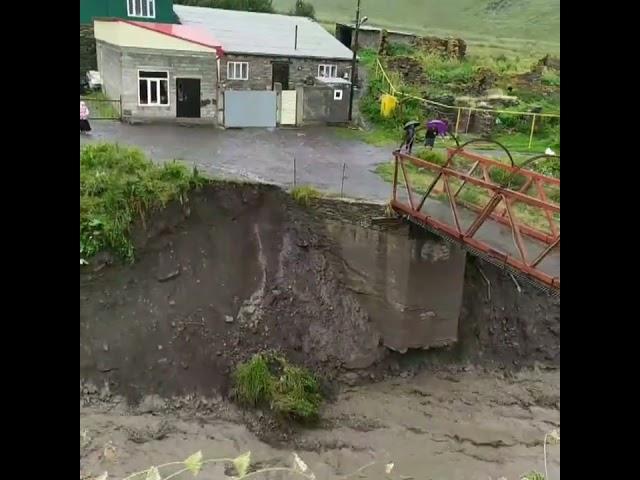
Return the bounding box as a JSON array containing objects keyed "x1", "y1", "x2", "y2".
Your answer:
[{"x1": 174, "y1": 5, "x2": 353, "y2": 127}]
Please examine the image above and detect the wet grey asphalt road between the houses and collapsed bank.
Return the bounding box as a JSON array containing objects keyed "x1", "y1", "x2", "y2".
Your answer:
[{"x1": 80, "y1": 122, "x2": 392, "y2": 201}]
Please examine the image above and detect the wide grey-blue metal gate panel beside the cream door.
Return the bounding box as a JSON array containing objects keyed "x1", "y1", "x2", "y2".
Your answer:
[{"x1": 224, "y1": 90, "x2": 276, "y2": 128}]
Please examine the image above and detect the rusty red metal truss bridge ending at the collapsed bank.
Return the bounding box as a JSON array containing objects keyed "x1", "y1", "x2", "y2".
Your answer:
[{"x1": 391, "y1": 141, "x2": 560, "y2": 290}]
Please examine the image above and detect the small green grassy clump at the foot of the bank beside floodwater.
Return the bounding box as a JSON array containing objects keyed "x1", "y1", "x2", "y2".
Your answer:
[{"x1": 233, "y1": 354, "x2": 322, "y2": 420}]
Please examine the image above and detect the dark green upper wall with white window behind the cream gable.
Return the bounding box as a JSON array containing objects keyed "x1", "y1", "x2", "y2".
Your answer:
[{"x1": 80, "y1": 0, "x2": 179, "y2": 25}]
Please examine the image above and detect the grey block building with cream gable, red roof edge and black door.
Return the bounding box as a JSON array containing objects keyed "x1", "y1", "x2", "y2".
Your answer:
[{"x1": 94, "y1": 19, "x2": 223, "y2": 123}]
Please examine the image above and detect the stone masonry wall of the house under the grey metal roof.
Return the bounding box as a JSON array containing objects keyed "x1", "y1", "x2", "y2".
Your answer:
[{"x1": 220, "y1": 54, "x2": 351, "y2": 90}]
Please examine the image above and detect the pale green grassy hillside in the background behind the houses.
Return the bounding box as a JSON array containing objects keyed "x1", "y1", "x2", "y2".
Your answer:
[{"x1": 273, "y1": 0, "x2": 560, "y2": 53}]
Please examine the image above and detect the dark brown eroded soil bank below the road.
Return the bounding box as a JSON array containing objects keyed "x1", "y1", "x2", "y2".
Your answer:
[{"x1": 80, "y1": 184, "x2": 560, "y2": 400}]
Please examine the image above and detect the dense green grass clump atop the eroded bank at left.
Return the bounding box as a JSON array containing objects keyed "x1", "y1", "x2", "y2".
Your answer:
[{"x1": 80, "y1": 144, "x2": 204, "y2": 260}]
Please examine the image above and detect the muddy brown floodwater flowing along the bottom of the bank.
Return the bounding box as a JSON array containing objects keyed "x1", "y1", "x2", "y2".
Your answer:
[{"x1": 80, "y1": 368, "x2": 560, "y2": 480}]
